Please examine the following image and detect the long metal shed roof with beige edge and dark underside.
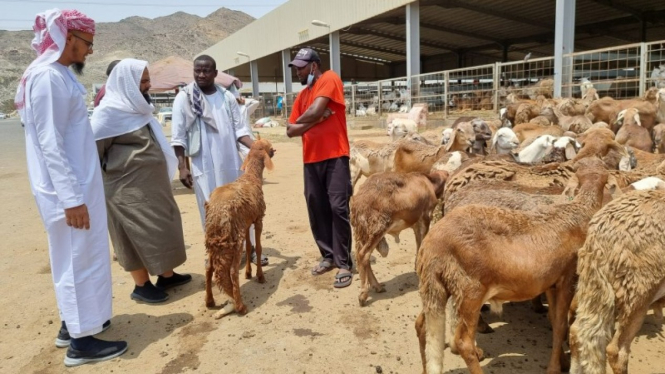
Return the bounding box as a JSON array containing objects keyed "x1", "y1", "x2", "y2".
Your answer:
[{"x1": 204, "y1": 0, "x2": 665, "y2": 77}]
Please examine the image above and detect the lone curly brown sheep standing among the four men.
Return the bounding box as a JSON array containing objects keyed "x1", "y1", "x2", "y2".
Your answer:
[{"x1": 205, "y1": 139, "x2": 273, "y2": 319}]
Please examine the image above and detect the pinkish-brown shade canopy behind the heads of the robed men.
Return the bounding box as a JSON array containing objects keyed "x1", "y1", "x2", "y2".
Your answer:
[{"x1": 148, "y1": 56, "x2": 242, "y2": 92}]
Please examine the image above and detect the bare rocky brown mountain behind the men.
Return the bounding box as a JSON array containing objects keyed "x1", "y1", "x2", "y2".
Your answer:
[{"x1": 0, "y1": 8, "x2": 254, "y2": 112}]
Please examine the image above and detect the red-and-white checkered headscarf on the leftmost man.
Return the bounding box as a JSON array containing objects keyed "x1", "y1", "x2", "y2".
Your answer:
[{"x1": 14, "y1": 8, "x2": 95, "y2": 111}]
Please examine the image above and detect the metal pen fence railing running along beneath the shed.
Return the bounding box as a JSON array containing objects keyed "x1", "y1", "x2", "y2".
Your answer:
[{"x1": 266, "y1": 40, "x2": 665, "y2": 117}]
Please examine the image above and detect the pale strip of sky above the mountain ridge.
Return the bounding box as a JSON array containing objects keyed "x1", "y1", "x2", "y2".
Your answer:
[{"x1": 0, "y1": 0, "x2": 287, "y2": 31}]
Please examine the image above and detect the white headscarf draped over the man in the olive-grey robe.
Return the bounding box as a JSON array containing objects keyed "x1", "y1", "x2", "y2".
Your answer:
[{"x1": 90, "y1": 58, "x2": 178, "y2": 179}]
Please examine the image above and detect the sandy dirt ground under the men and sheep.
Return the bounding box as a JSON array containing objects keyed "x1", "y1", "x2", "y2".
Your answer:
[{"x1": 0, "y1": 120, "x2": 665, "y2": 374}]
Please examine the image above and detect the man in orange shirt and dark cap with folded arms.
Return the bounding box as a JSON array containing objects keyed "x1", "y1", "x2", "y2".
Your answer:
[{"x1": 286, "y1": 48, "x2": 353, "y2": 288}]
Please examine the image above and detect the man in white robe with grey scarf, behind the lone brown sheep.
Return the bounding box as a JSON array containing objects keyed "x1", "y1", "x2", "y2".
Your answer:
[{"x1": 171, "y1": 55, "x2": 268, "y2": 265}]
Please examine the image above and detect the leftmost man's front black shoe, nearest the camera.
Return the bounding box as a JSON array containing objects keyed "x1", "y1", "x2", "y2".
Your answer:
[{"x1": 65, "y1": 336, "x2": 127, "y2": 366}]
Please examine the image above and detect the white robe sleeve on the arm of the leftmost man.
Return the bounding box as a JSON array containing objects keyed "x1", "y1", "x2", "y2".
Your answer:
[{"x1": 30, "y1": 70, "x2": 84, "y2": 209}]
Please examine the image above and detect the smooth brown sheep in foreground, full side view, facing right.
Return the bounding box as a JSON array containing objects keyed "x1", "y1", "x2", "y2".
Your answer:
[{"x1": 416, "y1": 158, "x2": 608, "y2": 374}]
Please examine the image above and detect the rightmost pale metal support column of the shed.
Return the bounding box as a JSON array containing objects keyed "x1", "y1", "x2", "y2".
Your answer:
[{"x1": 554, "y1": 0, "x2": 576, "y2": 97}]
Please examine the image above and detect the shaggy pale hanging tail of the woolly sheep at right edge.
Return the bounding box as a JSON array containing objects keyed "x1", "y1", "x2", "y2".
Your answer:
[{"x1": 570, "y1": 237, "x2": 615, "y2": 374}]
